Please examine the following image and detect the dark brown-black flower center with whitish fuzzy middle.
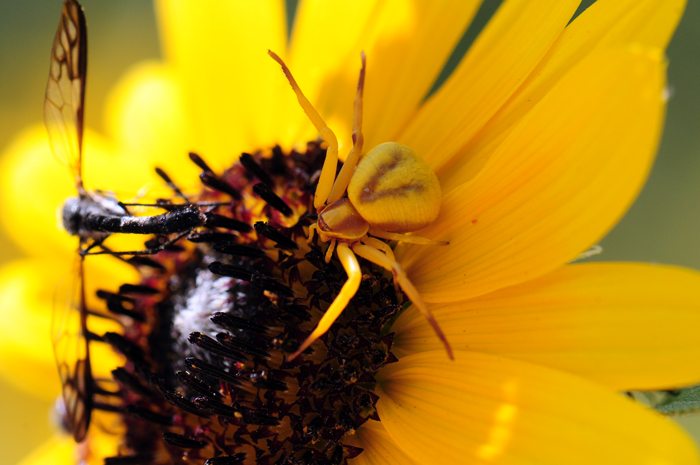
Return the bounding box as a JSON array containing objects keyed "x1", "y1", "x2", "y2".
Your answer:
[{"x1": 104, "y1": 143, "x2": 406, "y2": 465}]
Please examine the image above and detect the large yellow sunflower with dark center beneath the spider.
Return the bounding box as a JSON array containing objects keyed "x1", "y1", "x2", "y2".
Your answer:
[{"x1": 0, "y1": 0, "x2": 700, "y2": 465}]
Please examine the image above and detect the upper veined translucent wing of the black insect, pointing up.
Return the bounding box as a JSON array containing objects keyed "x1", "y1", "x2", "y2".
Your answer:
[{"x1": 44, "y1": 0, "x2": 87, "y2": 191}]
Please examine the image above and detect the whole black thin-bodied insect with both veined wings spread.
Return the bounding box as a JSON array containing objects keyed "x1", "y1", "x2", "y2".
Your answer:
[{"x1": 44, "y1": 0, "x2": 216, "y2": 442}]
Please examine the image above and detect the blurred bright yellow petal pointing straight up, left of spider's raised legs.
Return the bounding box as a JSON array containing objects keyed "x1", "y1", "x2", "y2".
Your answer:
[{"x1": 156, "y1": 0, "x2": 288, "y2": 166}]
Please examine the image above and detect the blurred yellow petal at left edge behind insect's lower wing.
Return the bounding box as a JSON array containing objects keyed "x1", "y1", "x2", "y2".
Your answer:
[{"x1": 0, "y1": 256, "x2": 138, "y2": 399}]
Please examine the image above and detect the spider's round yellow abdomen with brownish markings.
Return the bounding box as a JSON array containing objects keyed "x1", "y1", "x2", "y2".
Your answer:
[{"x1": 348, "y1": 142, "x2": 442, "y2": 232}]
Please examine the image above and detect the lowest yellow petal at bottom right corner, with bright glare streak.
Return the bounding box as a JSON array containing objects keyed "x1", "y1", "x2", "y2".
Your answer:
[{"x1": 377, "y1": 351, "x2": 700, "y2": 465}]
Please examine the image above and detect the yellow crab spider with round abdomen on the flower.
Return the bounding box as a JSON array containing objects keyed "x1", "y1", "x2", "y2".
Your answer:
[{"x1": 268, "y1": 51, "x2": 453, "y2": 360}]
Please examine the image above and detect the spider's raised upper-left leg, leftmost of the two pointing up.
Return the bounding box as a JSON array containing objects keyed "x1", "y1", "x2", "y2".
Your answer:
[{"x1": 267, "y1": 50, "x2": 338, "y2": 210}]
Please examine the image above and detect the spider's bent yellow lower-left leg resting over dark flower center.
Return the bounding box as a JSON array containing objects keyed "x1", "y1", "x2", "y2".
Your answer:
[{"x1": 287, "y1": 242, "x2": 362, "y2": 361}]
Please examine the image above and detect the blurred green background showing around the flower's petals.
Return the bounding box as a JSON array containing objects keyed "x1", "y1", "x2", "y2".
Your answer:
[{"x1": 0, "y1": 0, "x2": 700, "y2": 464}]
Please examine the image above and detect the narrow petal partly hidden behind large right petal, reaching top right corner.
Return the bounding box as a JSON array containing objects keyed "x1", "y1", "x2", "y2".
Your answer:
[{"x1": 440, "y1": 0, "x2": 685, "y2": 192}]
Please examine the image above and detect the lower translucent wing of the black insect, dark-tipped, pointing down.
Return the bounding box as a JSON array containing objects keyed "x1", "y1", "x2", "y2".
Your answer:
[{"x1": 51, "y1": 257, "x2": 94, "y2": 442}]
